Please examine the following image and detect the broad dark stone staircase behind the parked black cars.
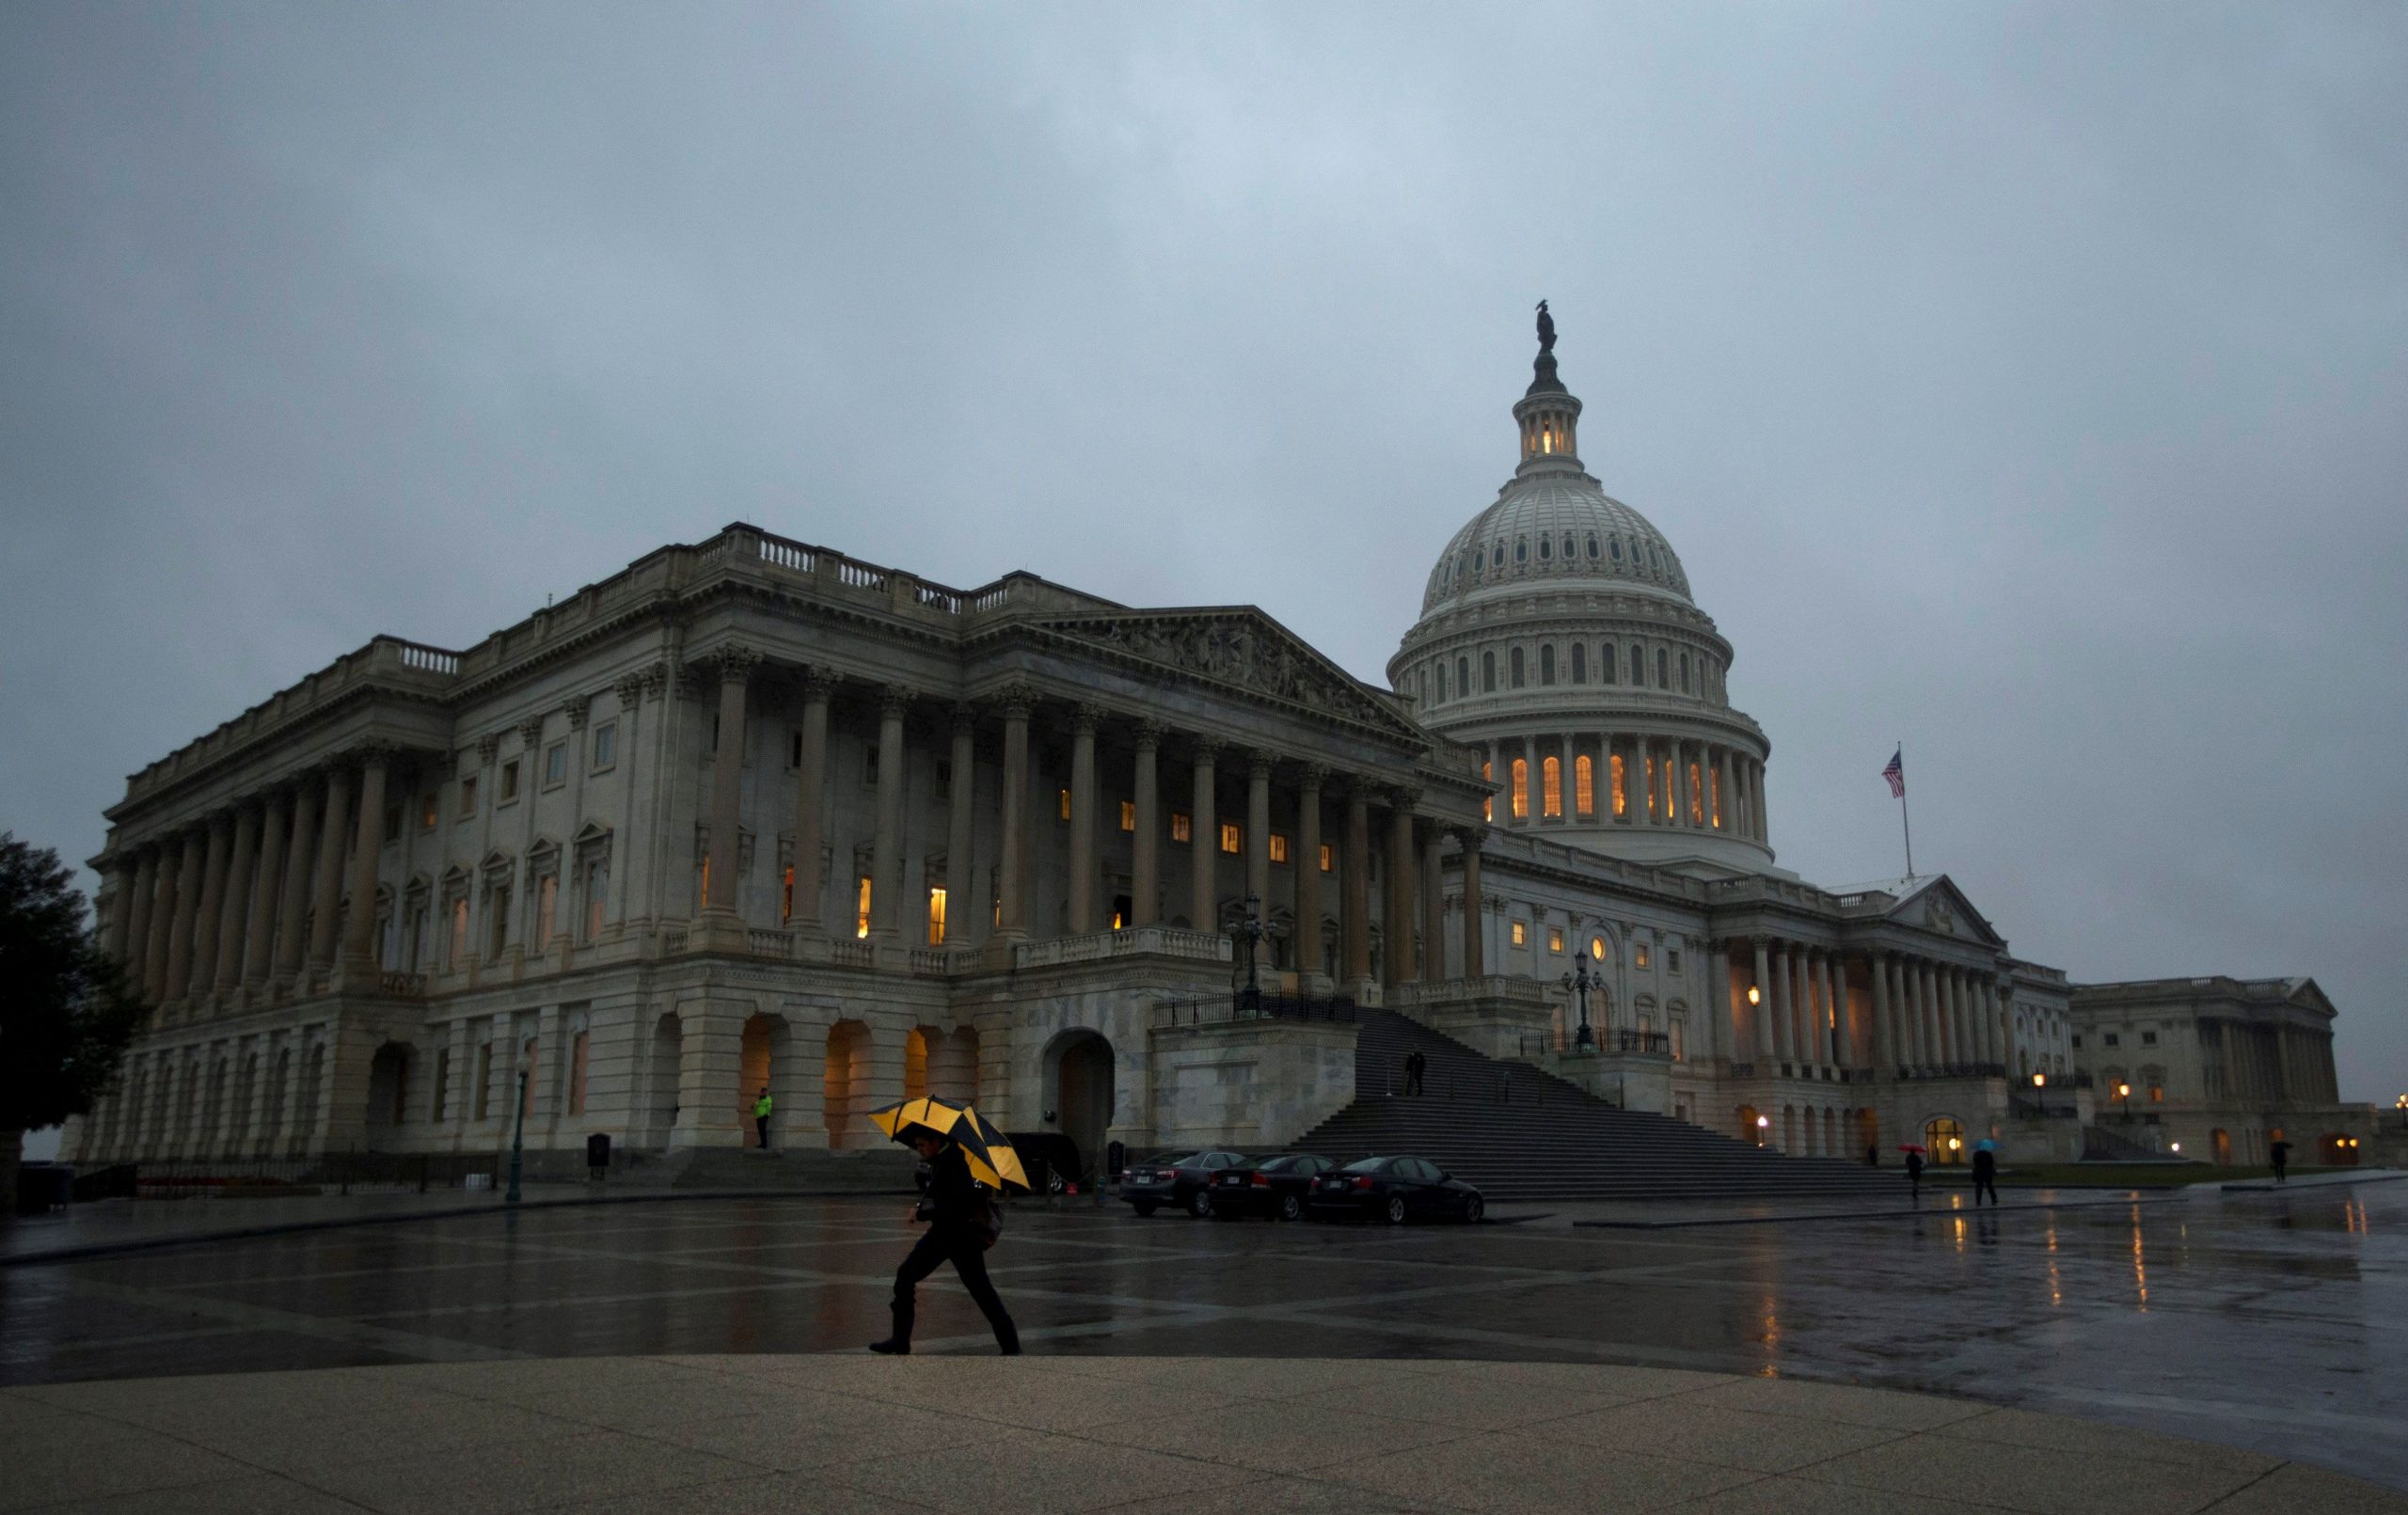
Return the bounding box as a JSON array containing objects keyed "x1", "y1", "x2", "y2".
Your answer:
[{"x1": 1293, "y1": 1007, "x2": 1905, "y2": 1205}]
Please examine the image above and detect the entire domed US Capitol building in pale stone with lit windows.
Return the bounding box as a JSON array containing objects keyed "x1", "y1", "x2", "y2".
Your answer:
[{"x1": 68, "y1": 318, "x2": 2372, "y2": 1168}]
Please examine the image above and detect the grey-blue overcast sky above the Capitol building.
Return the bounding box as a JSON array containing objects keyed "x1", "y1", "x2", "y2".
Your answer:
[{"x1": 0, "y1": 0, "x2": 2408, "y2": 1106}]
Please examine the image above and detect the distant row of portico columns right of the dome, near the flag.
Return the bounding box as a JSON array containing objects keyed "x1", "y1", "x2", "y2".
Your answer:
[{"x1": 1732, "y1": 937, "x2": 2013, "y2": 1074}]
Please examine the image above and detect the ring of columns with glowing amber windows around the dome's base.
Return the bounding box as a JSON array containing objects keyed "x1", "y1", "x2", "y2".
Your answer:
[{"x1": 1486, "y1": 730, "x2": 1767, "y2": 841}]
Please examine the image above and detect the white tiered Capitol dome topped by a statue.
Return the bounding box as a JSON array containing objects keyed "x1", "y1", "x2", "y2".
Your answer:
[{"x1": 1387, "y1": 304, "x2": 1772, "y2": 875}]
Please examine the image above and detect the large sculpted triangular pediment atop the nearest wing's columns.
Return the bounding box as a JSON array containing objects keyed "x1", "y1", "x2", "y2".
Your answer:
[{"x1": 1038, "y1": 605, "x2": 1431, "y2": 747}]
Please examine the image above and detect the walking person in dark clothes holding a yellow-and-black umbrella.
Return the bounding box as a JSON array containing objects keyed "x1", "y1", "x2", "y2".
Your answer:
[{"x1": 869, "y1": 1098, "x2": 1028, "y2": 1356}]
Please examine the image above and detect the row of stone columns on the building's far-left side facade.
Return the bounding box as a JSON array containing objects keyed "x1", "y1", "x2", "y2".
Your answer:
[{"x1": 103, "y1": 744, "x2": 395, "y2": 1004}]
